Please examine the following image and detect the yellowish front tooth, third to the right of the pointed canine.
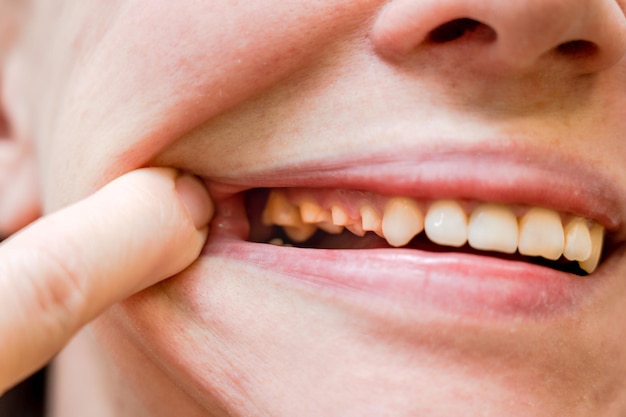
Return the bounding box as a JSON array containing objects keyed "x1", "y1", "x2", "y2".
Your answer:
[{"x1": 518, "y1": 207, "x2": 565, "y2": 261}]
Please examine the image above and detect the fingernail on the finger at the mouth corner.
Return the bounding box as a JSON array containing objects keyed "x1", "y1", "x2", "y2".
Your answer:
[{"x1": 175, "y1": 174, "x2": 215, "y2": 229}]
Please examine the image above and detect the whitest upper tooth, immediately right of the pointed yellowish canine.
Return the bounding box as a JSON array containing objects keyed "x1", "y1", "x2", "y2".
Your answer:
[{"x1": 424, "y1": 200, "x2": 467, "y2": 248}]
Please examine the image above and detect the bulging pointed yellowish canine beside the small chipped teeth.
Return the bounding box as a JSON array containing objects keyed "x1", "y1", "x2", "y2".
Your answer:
[{"x1": 382, "y1": 197, "x2": 424, "y2": 247}]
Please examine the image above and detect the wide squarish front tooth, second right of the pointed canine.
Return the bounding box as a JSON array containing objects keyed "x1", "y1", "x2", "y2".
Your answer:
[{"x1": 467, "y1": 204, "x2": 518, "y2": 253}]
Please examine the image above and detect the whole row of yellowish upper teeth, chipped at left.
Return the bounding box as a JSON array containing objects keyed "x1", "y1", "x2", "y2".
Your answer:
[{"x1": 263, "y1": 190, "x2": 604, "y2": 273}]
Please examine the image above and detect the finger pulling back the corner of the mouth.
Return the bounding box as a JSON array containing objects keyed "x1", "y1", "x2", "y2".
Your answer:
[{"x1": 0, "y1": 168, "x2": 213, "y2": 393}]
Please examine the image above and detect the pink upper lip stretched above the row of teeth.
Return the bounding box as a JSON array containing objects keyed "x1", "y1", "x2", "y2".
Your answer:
[{"x1": 209, "y1": 142, "x2": 626, "y2": 242}]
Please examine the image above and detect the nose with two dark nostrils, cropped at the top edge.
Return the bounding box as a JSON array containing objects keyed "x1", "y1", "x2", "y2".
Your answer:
[{"x1": 370, "y1": 0, "x2": 626, "y2": 74}]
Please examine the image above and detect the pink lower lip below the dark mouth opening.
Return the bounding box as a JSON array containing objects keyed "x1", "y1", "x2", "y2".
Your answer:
[{"x1": 203, "y1": 236, "x2": 607, "y2": 318}]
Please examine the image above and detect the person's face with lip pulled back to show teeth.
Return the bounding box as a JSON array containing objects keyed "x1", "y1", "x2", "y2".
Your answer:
[{"x1": 5, "y1": 0, "x2": 626, "y2": 416}]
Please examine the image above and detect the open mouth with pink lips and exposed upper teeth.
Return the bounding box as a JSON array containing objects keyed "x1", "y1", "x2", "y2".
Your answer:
[{"x1": 204, "y1": 145, "x2": 624, "y2": 316}]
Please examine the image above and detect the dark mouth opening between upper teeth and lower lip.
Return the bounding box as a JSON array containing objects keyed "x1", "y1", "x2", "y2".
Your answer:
[{"x1": 244, "y1": 189, "x2": 588, "y2": 276}]
